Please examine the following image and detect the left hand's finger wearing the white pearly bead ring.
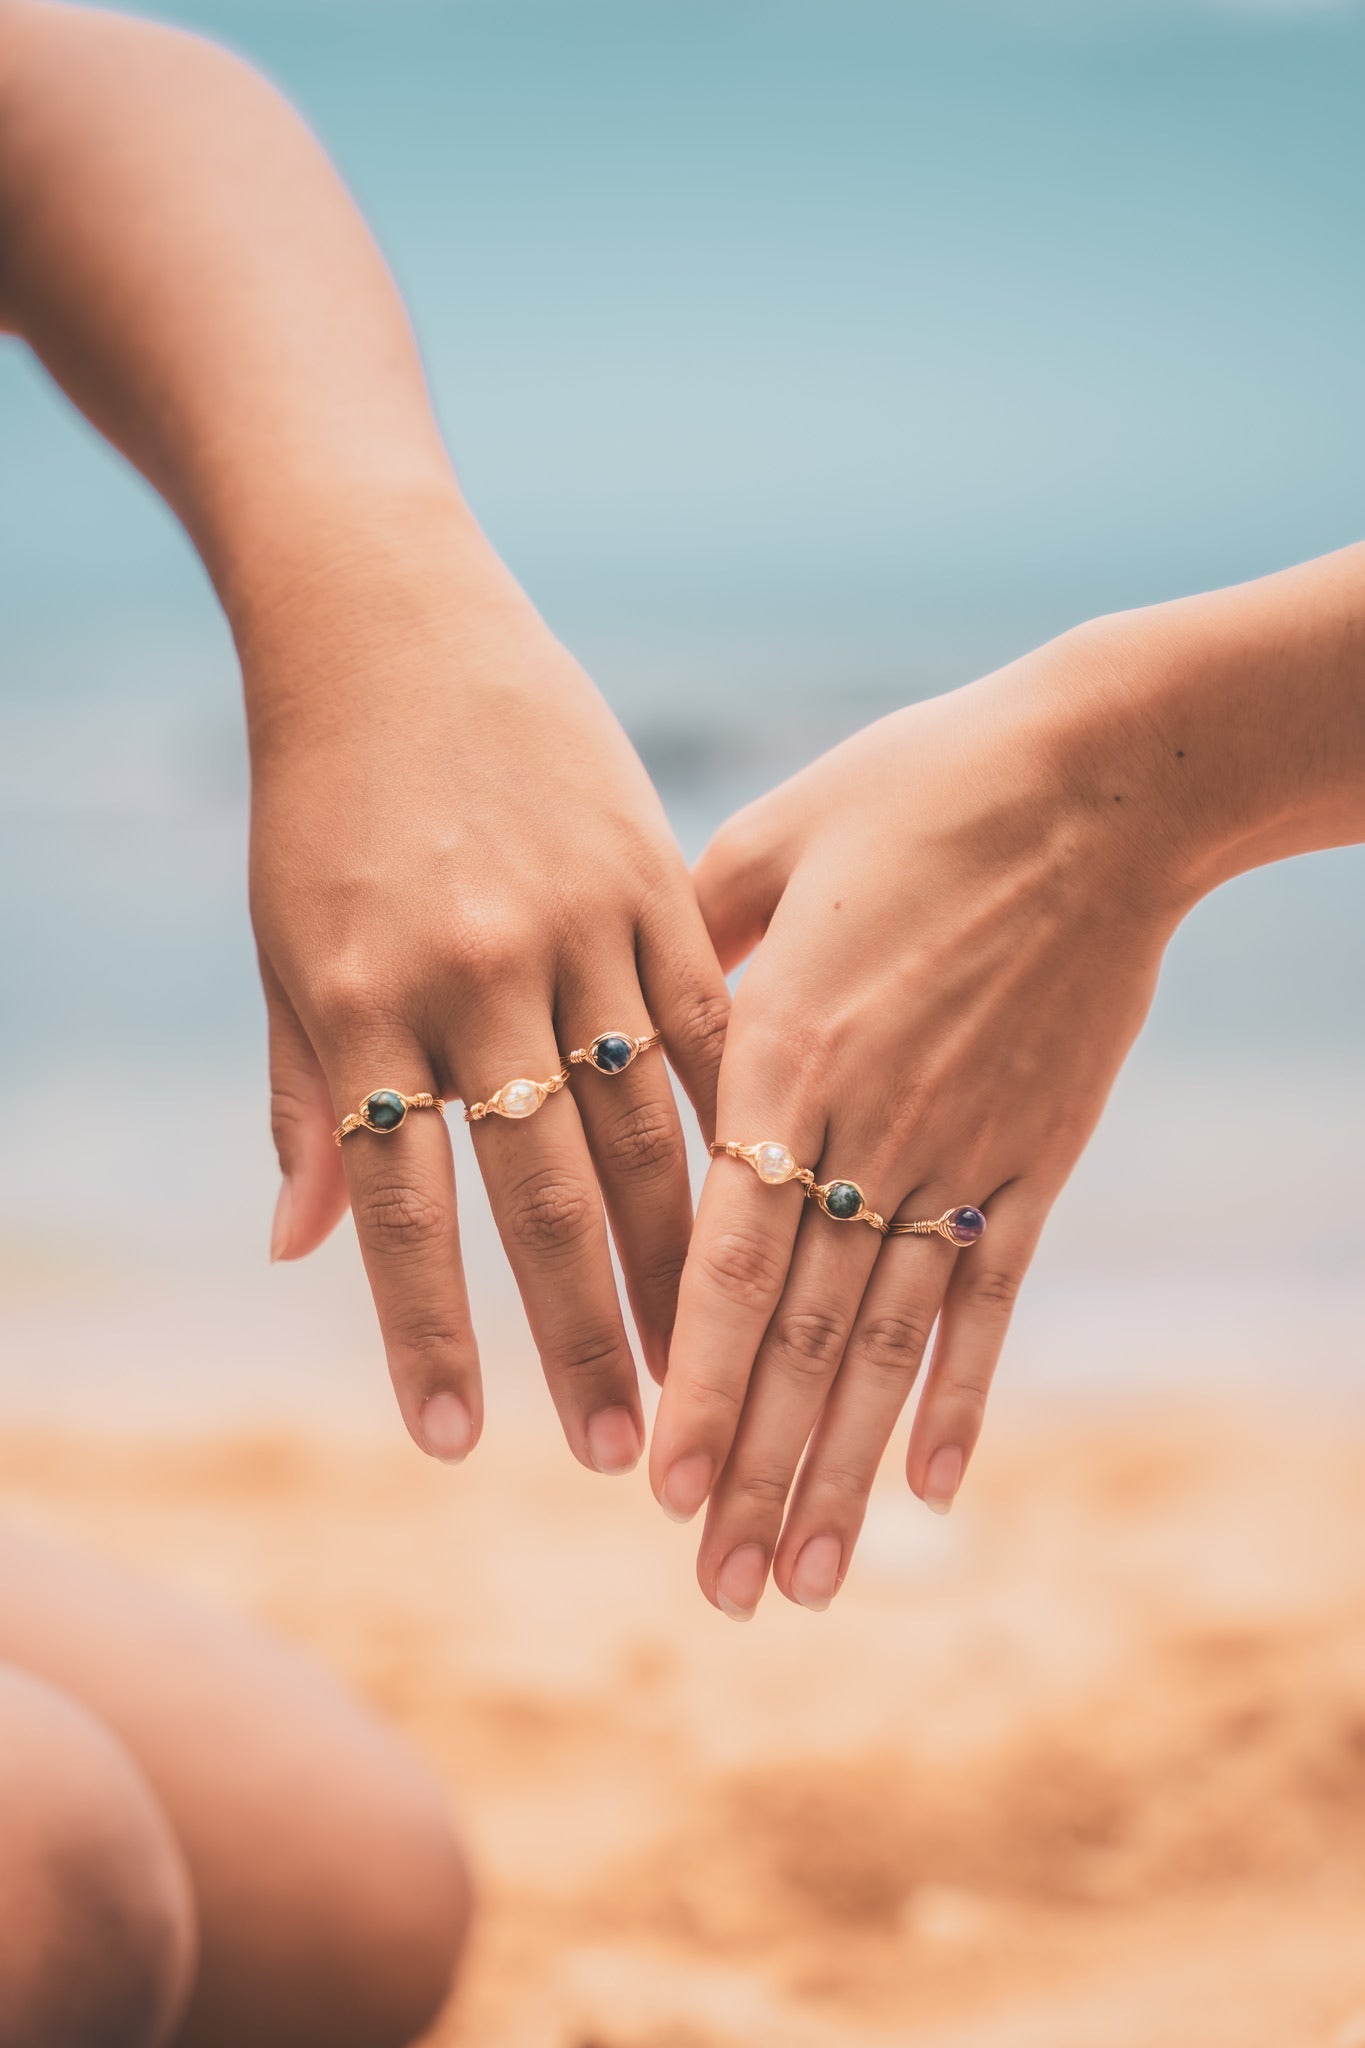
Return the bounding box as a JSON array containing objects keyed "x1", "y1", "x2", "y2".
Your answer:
[{"x1": 450, "y1": 1001, "x2": 645, "y2": 1473}]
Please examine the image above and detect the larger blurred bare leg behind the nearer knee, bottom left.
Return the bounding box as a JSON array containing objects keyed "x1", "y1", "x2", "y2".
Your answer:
[{"x1": 0, "y1": 1528, "x2": 469, "y2": 2048}]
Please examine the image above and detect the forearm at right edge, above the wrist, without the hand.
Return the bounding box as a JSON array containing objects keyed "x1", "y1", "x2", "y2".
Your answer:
[{"x1": 1035, "y1": 545, "x2": 1365, "y2": 909}]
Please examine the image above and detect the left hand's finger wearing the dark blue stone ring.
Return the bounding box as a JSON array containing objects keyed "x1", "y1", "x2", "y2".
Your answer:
[{"x1": 561, "y1": 977, "x2": 692, "y2": 1380}]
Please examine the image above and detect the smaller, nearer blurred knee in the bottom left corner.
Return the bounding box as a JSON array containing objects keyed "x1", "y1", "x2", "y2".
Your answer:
[{"x1": 0, "y1": 1669, "x2": 194, "y2": 2048}]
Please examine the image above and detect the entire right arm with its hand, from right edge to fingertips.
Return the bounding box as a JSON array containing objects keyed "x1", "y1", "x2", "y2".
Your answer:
[{"x1": 651, "y1": 547, "x2": 1365, "y2": 1620}]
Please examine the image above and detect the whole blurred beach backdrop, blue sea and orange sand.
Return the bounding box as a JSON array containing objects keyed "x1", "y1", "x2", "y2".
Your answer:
[{"x1": 0, "y1": 0, "x2": 1365, "y2": 2048}]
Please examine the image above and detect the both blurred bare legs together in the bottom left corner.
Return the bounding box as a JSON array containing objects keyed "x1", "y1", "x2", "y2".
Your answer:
[{"x1": 0, "y1": 1524, "x2": 469, "y2": 2048}]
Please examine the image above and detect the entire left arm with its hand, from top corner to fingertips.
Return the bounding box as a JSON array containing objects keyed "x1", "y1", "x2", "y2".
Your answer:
[{"x1": 0, "y1": 0, "x2": 729, "y2": 1473}]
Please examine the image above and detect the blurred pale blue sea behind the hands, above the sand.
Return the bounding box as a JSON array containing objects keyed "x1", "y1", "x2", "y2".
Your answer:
[{"x1": 0, "y1": 0, "x2": 1365, "y2": 1423}]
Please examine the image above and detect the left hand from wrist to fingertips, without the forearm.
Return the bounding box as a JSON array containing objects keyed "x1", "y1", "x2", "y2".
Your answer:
[{"x1": 249, "y1": 514, "x2": 729, "y2": 1473}]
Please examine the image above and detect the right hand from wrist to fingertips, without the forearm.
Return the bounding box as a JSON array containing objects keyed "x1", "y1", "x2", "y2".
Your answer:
[{"x1": 651, "y1": 629, "x2": 1177, "y2": 1618}]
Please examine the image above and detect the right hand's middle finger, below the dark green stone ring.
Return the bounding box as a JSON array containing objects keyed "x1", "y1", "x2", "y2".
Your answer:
[{"x1": 698, "y1": 1179, "x2": 882, "y2": 1620}]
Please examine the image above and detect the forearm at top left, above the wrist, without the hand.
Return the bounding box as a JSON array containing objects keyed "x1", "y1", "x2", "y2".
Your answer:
[{"x1": 0, "y1": 0, "x2": 465, "y2": 631}]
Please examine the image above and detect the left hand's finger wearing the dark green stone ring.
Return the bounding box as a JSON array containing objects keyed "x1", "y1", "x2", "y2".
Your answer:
[{"x1": 327, "y1": 1024, "x2": 483, "y2": 1462}]
